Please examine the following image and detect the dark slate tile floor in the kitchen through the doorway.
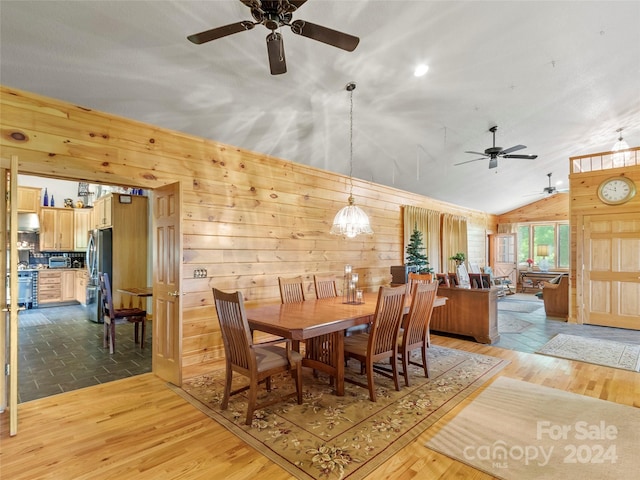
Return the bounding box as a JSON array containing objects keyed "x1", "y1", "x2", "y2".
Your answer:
[{"x1": 18, "y1": 305, "x2": 152, "y2": 402}]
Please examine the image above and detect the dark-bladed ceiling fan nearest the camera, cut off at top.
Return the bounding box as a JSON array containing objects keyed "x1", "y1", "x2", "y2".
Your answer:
[{"x1": 187, "y1": 0, "x2": 360, "y2": 75}]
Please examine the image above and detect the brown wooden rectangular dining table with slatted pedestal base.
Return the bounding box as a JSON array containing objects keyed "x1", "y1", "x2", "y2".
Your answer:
[{"x1": 246, "y1": 292, "x2": 446, "y2": 396}]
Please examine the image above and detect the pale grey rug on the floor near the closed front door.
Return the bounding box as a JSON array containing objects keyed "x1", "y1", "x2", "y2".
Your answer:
[{"x1": 536, "y1": 333, "x2": 640, "y2": 372}]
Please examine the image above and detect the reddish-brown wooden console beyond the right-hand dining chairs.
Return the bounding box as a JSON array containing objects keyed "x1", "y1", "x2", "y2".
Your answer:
[{"x1": 429, "y1": 285, "x2": 500, "y2": 343}]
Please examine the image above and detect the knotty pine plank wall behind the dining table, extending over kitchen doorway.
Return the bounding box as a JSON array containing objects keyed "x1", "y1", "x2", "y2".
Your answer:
[{"x1": 0, "y1": 87, "x2": 497, "y2": 377}]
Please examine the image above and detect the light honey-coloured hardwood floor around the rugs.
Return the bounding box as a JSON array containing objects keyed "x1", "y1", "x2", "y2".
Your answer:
[{"x1": 0, "y1": 335, "x2": 640, "y2": 480}]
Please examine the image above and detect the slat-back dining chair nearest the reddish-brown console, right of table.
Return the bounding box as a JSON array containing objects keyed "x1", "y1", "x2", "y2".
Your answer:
[{"x1": 398, "y1": 283, "x2": 438, "y2": 387}]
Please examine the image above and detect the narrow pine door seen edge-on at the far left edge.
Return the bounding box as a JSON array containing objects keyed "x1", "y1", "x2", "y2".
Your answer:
[{"x1": 0, "y1": 155, "x2": 18, "y2": 436}]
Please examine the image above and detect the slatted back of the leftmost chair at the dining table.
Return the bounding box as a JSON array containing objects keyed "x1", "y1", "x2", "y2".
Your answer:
[{"x1": 213, "y1": 288, "x2": 255, "y2": 370}]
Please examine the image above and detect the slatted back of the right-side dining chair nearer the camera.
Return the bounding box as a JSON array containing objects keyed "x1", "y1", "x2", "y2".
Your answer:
[{"x1": 368, "y1": 285, "x2": 407, "y2": 356}]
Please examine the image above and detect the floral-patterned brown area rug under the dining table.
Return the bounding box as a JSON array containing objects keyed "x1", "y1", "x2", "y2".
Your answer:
[{"x1": 174, "y1": 345, "x2": 509, "y2": 480}]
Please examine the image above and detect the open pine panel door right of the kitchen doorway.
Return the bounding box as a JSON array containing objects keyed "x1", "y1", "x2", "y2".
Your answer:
[{"x1": 153, "y1": 183, "x2": 182, "y2": 386}]
